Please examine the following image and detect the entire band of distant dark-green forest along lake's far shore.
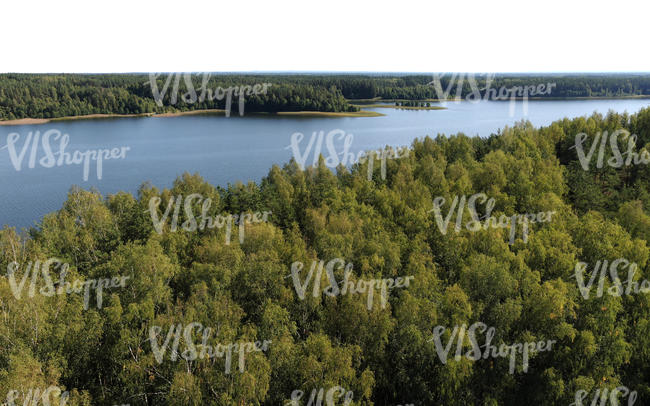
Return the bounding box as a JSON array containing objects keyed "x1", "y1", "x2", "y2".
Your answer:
[{"x1": 0, "y1": 74, "x2": 650, "y2": 120}]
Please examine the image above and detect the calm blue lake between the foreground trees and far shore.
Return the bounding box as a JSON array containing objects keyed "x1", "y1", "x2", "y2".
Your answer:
[{"x1": 0, "y1": 99, "x2": 650, "y2": 228}]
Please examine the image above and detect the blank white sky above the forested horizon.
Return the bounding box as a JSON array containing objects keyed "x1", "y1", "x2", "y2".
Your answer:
[{"x1": 0, "y1": 0, "x2": 650, "y2": 73}]
